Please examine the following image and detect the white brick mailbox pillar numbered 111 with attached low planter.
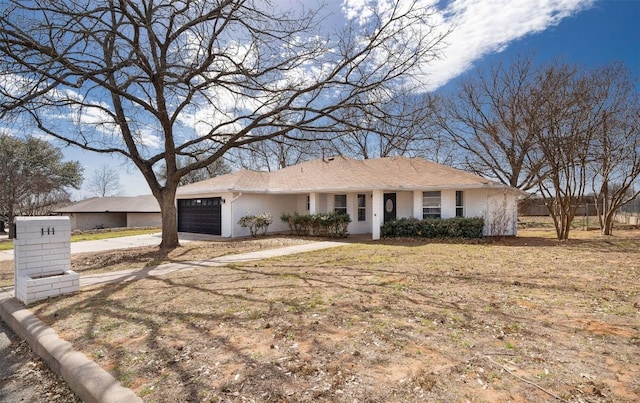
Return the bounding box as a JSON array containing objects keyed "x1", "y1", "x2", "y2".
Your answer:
[{"x1": 13, "y1": 217, "x2": 80, "y2": 305}]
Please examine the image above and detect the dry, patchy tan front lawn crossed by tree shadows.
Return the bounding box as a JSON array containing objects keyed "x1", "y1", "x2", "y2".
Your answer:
[{"x1": 11, "y1": 230, "x2": 640, "y2": 402}]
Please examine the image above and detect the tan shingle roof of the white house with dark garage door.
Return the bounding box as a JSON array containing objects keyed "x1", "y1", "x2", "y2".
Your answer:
[{"x1": 178, "y1": 157, "x2": 506, "y2": 197}]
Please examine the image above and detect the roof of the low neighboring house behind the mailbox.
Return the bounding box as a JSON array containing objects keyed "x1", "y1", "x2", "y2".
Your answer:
[{"x1": 55, "y1": 195, "x2": 160, "y2": 213}]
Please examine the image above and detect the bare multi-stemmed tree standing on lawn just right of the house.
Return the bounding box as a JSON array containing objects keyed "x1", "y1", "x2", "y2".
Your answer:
[{"x1": 529, "y1": 63, "x2": 602, "y2": 240}]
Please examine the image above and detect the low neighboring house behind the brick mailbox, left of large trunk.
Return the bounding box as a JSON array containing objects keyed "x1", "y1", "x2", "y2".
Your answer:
[{"x1": 55, "y1": 195, "x2": 162, "y2": 230}]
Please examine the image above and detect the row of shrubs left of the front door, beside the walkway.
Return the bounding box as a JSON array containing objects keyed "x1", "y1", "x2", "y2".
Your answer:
[{"x1": 280, "y1": 212, "x2": 351, "y2": 238}]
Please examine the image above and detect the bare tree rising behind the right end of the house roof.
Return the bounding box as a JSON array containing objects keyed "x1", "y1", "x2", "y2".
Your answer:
[{"x1": 431, "y1": 57, "x2": 539, "y2": 191}]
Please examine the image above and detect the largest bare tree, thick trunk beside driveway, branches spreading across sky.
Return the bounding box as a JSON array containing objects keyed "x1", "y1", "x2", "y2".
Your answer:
[{"x1": 0, "y1": 0, "x2": 446, "y2": 248}]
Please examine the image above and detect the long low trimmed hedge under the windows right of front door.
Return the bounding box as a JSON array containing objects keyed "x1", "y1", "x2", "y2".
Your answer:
[{"x1": 380, "y1": 217, "x2": 484, "y2": 239}]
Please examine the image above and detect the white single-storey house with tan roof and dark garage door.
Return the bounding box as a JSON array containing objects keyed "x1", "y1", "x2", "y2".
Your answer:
[{"x1": 176, "y1": 157, "x2": 523, "y2": 239}]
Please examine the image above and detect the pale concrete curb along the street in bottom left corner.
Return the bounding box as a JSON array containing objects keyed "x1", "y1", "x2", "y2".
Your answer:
[{"x1": 0, "y1": 289, "x2": 142, "y2": 403}]
